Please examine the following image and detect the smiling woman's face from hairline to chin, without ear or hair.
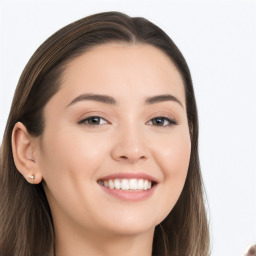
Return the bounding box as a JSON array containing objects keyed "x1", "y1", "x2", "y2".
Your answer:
[{"x1": 36, "y1": 43, "x2": 191, "y2": 238}]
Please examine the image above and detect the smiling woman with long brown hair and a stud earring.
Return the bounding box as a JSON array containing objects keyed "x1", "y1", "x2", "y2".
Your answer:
[{"x1": 0, "y1": 12, "x2": 209, "y2": 256}]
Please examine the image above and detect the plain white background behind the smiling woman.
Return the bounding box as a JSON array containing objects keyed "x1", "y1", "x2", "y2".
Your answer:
[{"x1": 0, "y1": 0, "x2": 256, "y2": 256}]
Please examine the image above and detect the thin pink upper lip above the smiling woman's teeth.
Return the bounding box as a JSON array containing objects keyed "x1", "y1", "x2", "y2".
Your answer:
[{"x1": 98, "y1": 172, "x2": 159, "y2": 183}]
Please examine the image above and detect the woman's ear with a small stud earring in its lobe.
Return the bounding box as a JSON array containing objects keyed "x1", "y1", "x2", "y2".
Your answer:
[{"x1": 12, "y1": 122, "x2": 42, "y2": 184}]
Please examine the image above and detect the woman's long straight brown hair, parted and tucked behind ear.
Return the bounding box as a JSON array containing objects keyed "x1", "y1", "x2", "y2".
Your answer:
[{"x1": 0, "y1": 12, "x2": 209, "y2": 256}]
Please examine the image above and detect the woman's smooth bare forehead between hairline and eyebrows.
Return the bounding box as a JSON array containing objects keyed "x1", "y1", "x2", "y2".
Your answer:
[{"x1": 51, "y1": 43, "x2": 185, "y2": 106}]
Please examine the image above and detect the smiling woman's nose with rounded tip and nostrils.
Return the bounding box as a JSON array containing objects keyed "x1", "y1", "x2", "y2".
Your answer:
[{"x1": 111, "y1": 125, "x2": 149, "y2": 163}]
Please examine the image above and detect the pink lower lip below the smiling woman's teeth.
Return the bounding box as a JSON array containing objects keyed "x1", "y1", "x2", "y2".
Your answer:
[{"x1": 99, "y1": 185, "x2": 157, "y2": 202}]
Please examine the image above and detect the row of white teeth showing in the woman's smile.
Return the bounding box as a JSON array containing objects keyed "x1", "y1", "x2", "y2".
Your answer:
[{"x1": 98, "y1": 179, "x2": 152, "y2": 190}]
